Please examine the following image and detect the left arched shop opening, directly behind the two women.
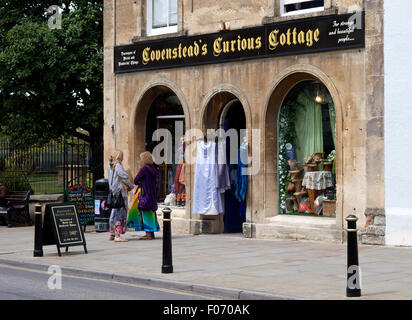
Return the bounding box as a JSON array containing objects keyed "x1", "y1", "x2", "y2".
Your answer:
[{"x1": 133, "y1": 85, "x2": 190, "y2": 208}]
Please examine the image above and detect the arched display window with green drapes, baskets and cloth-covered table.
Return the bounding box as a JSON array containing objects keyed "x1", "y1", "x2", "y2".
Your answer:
[{"x1": 277, "y1": 80, "x2": 336, "y2": 216}]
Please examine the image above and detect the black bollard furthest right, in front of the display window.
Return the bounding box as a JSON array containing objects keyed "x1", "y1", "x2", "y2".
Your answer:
[{"x1": 346, "y1": 215, "x2": 361, "y2": 298}]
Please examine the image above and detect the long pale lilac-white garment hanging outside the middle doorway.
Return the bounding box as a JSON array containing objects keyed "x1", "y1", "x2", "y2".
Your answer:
[{"x1": 192, "y1": 141, "x2": 223, "y2": 215}]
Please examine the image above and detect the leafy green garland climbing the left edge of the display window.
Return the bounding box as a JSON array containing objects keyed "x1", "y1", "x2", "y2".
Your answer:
[{"x1": 278, "y1": 101, "x2": 296, "y2": 213}]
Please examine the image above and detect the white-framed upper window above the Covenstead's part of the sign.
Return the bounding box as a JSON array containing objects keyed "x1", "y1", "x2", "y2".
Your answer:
[{"x1": 146, "y1": 0, "x2": 177, "y2": 35}]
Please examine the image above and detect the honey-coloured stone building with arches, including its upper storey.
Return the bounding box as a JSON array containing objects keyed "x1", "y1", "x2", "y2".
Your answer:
[{"x1": 104, "y1": 0, "x2": 410, "y2": 244}]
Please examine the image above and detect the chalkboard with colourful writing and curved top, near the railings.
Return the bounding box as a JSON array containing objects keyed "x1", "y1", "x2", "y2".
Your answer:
[{"x1": 64, "y1": 184, "x2": 95, "y2": 226}]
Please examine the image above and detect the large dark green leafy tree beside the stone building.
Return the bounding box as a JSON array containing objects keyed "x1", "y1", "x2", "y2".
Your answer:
[{"x1": 0, "y1": 0, "x2": 103, "y2": 178}]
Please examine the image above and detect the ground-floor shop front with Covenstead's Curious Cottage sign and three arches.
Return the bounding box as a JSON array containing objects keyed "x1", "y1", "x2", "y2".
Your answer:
[{"x1": 105, "y1": 6, "x2": 380, "y2": 242}]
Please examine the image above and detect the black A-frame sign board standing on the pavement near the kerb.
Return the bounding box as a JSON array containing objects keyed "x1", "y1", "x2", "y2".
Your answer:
[{"x1": 43, "y1": 203, "x2": 87, "y2": 256}]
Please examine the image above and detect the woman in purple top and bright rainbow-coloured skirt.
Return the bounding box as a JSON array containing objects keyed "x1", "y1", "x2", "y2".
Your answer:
[{"x1": 128, "y1": 151, "x2": 160, "y2": 240}]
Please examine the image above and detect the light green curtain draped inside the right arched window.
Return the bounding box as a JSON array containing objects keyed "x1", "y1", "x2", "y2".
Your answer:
[{"x1": 295, "y1": 92, "x2": 323, "y2": 164}]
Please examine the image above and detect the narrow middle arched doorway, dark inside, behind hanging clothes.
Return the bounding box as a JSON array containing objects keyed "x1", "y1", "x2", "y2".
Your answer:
[{"x1": 203, "y1": 92, "x2": 248, "y2": 233}]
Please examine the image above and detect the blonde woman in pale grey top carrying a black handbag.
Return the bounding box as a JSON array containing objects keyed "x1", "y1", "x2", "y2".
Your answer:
[{"x1": 108, "y1": 150, "x2": 134, "y2": 242}]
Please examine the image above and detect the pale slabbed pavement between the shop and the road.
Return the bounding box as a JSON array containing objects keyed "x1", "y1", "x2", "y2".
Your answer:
[{"x1": 0, "y1": 226, "x2": 412, "y2": 300}]
